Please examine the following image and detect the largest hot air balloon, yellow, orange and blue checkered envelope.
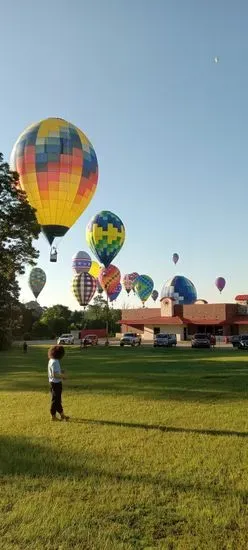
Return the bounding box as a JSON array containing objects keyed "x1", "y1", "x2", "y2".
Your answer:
[{"x1": 10, "y1": 118, "x2": 98, "y2": 261}]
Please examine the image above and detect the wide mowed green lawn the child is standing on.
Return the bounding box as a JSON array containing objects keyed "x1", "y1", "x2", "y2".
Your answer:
[{"x1": 0, "y1": 347, "x2": 248, "y2": 550}]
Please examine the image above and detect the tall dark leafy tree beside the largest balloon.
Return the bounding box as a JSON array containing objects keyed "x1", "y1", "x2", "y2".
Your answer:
[{"x1": 0, "y1": 153, "x2": 40, "y2": 349}]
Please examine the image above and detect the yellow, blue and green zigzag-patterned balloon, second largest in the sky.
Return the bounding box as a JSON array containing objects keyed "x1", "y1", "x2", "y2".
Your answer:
[{"x1": 86, "y1": 210, "x2": 125, "y2": 267}]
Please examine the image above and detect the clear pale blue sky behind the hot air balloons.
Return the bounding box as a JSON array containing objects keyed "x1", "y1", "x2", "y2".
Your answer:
[{"x1": 0, "y1": 0, "x2": 248, "y2": 309}]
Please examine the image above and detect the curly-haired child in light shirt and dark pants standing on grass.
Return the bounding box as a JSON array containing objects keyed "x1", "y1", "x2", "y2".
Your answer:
[{"x1": 48, "y1": 346, "x2": 69, "y2": 421}]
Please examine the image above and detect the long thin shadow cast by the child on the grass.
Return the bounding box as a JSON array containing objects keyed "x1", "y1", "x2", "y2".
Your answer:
[{"x1": 70, "y1": 417, "x2": 248, "y2": 437}]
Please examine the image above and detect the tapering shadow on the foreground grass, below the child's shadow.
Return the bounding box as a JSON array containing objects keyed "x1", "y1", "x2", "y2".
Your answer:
[{"x1": 0, "y1": 436, "x2": 248, "y2": 503}]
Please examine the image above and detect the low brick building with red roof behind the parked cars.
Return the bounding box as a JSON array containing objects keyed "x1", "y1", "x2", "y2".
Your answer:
[{"x1": 120, "y1": 295, "x2": 248, "y2": 341}]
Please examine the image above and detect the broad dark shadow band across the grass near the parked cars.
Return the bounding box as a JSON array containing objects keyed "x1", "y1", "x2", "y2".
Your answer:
[{"x1": 0, "y1": 347, "x2": 248, "y2": 402}]
